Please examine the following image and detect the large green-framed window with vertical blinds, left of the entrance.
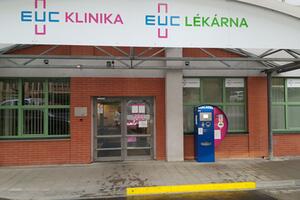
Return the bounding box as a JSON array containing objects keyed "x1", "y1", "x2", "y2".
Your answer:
[{"x1": 0, "y1": 79, "x2": 70, "y2": 139}]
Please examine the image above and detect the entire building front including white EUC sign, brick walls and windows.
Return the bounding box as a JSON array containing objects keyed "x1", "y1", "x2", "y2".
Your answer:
[{"x1": 0, "y1": 0, "x2": 300, "y2": 166}]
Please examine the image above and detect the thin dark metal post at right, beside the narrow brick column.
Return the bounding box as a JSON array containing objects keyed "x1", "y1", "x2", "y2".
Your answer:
[{"x1": 267, "y1": 72, "x2": 273, "y2": 160}]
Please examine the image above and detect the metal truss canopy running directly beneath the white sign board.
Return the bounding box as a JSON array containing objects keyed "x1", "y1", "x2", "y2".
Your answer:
[{"x1": 0, "y1": 45, "x2": 300, "y2": 73}]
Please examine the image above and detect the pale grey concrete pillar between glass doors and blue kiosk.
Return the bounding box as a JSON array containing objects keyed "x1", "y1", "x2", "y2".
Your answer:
[{"x1": 165, "y1": 49, "x2": 184, "y2": 161}]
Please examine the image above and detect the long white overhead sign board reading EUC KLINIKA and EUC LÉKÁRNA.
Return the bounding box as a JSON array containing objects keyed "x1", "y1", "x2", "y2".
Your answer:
[{"x1": 0, "y1": 0, "x2": 300, "y2": 48}]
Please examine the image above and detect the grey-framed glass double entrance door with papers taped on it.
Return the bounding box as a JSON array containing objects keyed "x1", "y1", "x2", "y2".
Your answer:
[{"x1": 94, "y1": 97, "x2": 154, "y2": 161}]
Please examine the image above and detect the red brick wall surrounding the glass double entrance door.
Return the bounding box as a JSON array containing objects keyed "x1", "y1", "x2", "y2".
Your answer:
[{"x1": 71, "y1": 78, "x2": 166, "y2": 163}]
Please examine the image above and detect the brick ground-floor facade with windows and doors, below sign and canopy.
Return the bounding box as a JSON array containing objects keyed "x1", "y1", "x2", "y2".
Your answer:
[{"x1": 0, "y1": 45, "x2": 300, "y2": 166}]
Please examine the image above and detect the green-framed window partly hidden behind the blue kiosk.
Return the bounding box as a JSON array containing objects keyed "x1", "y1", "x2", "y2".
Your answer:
[{"x1": 183, "y1": 78, "x2": 247, "y2": 134}]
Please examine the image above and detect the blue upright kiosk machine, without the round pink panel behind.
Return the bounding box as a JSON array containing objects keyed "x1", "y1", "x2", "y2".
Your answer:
[{"x1": 194, "y1": 106, "x2": 215, "y2": 162}]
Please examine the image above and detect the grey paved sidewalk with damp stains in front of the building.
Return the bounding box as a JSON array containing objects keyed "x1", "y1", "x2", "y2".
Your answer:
[{"x1": 0, "y1": 158, "x2": 300, "y2": 200}]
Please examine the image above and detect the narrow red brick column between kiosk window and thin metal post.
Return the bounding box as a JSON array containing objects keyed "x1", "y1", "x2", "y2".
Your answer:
[{"x1": 247, "y1": 77, "x2": 268, "y2": 157}]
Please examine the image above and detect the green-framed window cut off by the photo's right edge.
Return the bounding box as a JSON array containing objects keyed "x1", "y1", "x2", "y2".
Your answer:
[{"x1": 272, "y1": 78, "x2": 300, "y2": 132}]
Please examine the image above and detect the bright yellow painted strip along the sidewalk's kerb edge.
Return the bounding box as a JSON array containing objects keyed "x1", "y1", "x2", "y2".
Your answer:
[{"x1": 126, "y1": 182, "x2": 256, "y2": 196}]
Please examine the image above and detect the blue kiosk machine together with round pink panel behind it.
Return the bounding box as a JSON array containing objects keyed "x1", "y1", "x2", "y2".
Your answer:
[{"x1": 194, "y1": 105, "x2": 228, "y2": 162}]
